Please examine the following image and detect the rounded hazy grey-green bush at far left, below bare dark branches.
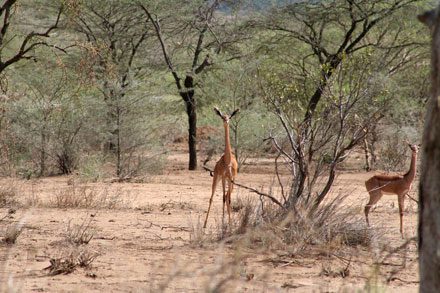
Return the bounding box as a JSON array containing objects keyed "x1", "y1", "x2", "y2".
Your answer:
[{"x1": 7, "y1": 59, "x2": 84, "y2": 176}]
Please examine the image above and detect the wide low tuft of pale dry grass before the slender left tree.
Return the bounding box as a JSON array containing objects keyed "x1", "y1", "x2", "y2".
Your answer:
[{"x1": 51, "y1": 184, "x2": 122, "y2": 209}]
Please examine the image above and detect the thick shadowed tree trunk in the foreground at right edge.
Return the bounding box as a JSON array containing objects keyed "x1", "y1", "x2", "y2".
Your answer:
[{"x1": 418, "y1": 6, "x2": 440, "y2": 292}]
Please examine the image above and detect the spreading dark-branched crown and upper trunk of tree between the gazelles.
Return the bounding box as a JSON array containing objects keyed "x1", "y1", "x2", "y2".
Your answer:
[{"x1": 266, "y1": 0, "x2": 421, "y2": 122}]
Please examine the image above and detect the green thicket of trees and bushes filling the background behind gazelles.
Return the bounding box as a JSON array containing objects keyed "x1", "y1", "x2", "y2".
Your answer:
[{"x1": 0, "y1": 0, "x2": 429, "y2": 193}]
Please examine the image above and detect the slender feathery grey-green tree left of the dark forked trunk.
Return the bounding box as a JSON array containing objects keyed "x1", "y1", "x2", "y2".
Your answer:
[{"x1": 69, "y1": 1, "x2": 150, "y2": 176}]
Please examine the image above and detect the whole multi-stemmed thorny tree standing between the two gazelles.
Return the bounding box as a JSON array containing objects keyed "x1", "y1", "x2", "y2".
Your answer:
[{"x1": 261, "y1": 0, "x2": 426, "y2": 205}]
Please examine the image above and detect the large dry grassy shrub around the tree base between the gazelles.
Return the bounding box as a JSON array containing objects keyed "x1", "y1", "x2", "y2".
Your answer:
[{"x1": 225, "y1": 194, "x2": 375, "y2": 253}]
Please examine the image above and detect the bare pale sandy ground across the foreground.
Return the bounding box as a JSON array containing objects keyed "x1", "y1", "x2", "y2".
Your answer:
[{"x1": 0, "y1": 154, "x2": 419, "y2": 292}]
